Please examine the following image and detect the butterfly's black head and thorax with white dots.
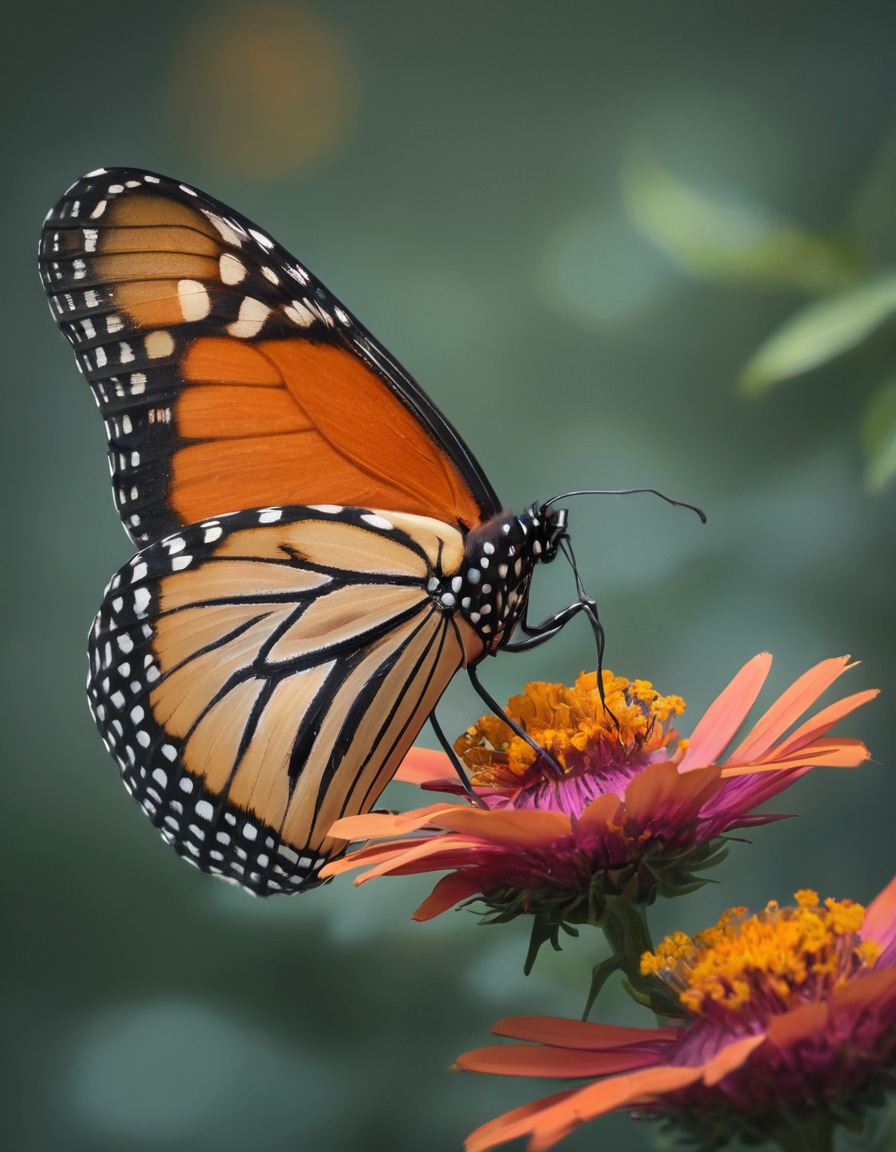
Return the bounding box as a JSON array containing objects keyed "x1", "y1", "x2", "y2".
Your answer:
[{"x1": 453, "y1": 505, "x2": 567, "y2": 652}]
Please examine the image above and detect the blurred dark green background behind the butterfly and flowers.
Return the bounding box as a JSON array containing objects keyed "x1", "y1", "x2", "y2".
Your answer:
[{"x1": 6, "y1": 0, "x2": 896, "y2": 1152}]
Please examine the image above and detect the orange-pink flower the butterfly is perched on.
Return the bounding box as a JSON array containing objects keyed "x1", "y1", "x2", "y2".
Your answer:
[{"x1": 321, "y1": 654, "x2": 876, "y2": 975}]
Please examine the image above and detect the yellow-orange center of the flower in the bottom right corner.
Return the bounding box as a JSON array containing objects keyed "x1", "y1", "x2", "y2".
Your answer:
[{"x1": 640, "y1": 889, "x2": 881, "y2": 1016}]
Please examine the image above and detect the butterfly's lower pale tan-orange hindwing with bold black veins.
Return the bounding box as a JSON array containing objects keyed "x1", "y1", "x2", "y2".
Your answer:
[{"x1": 88, "y1": 506, "x2": 481, "y2": 894}]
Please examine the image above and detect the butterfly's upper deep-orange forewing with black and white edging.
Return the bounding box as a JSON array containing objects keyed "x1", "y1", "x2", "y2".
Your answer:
[{"x1": 40, "y1": 169, "x2": 500, "y2": 544}]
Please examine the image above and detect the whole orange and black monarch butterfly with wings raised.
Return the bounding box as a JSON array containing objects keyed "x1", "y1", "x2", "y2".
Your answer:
[{"x1": 40, "y1": 168, "x2": 599, "y2": 895}]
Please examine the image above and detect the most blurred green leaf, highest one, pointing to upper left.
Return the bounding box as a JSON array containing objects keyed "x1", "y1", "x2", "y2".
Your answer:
[{"x1": 622, "y1": 143, "x2": 864, "y2": 293}]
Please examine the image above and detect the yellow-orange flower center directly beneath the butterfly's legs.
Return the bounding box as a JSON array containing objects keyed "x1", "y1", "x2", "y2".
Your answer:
[{"x1": 454, "y1": 669, "x2": 685, "y2": 788}]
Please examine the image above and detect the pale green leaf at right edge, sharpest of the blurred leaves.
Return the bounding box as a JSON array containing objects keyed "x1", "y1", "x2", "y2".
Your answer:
[{"x1": 741, "y1": 272, "x2": 896, "y2": 394}]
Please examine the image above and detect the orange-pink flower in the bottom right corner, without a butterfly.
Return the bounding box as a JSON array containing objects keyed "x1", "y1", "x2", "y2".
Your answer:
[{"x1": 457, "y1": 879, "x2": 896, "y2": 1152}]
